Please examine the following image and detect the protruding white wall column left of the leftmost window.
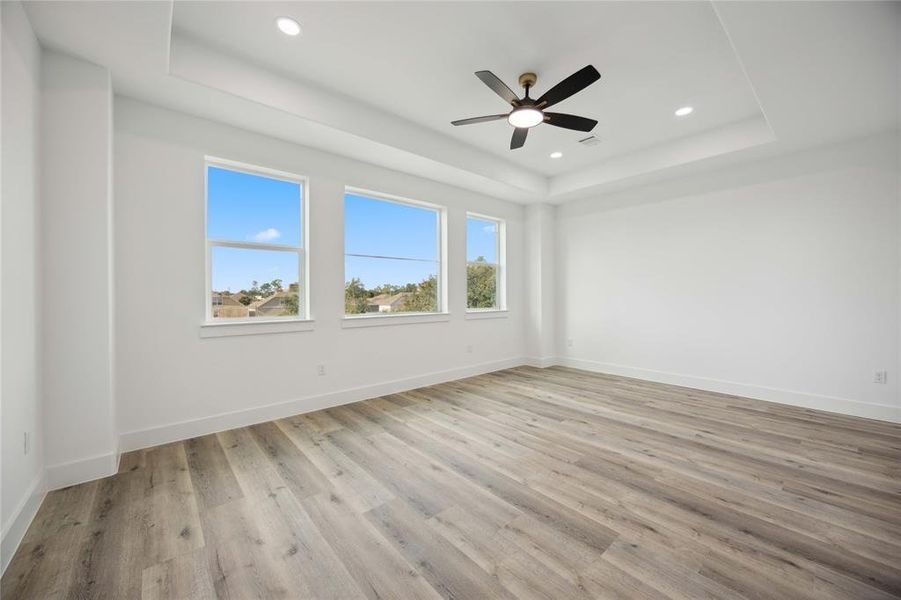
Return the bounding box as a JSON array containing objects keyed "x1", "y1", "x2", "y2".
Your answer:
[{"x1": 41, "y1": 52, "x2": 118, "y2": 488}]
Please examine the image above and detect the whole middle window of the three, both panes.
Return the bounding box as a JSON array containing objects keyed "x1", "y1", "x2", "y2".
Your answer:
[{"x1": 344, "y1": 189, "x2": 443, "y2": 316}]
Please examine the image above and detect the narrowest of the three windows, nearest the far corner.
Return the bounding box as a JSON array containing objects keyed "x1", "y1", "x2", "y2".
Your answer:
[{"x1": 466, "y1": 214, "x2": 506, "y2": 310}]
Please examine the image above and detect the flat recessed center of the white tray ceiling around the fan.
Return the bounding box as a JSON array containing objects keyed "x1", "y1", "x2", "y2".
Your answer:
[{"x1": 173, "y1": 1, "x2": 760, "y2": 175}]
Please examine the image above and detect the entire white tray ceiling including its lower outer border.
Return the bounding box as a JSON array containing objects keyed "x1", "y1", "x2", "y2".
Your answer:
[{"x1": 21, "y1": 1, "x2": 901, "y2": 202}]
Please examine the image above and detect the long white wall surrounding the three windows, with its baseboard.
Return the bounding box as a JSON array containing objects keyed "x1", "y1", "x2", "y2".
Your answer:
[{"x1": 114, "y1": 97, "x2": 525, "y2": 449}]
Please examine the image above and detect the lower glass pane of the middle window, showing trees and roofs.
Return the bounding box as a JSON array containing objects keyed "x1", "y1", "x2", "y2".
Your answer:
[{"x1": 344, "y1": 256, "x2": 439, "y2": 314}]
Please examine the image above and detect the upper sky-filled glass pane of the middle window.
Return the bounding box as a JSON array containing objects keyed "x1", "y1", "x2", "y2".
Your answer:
[{"x1": 344, "y1": 193, "x2": 438, "y2": 261}]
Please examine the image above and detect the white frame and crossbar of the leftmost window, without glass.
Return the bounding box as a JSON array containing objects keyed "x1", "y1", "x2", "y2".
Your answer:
[{"x1": 203, "y1": 155, "x2": 312, "y2": 326}]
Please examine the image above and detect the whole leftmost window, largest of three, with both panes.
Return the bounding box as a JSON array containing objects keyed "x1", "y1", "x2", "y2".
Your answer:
[{"x1": 206, "y1": 158, "x2": 307, "y2": 322}]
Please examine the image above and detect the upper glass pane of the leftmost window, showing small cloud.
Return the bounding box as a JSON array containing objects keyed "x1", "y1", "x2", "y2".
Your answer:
[{"x1": 207, "y1": 166, "x2": 303, "y2": 246}]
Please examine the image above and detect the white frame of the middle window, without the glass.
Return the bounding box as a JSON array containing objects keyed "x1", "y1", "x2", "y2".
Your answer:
[{"x1": 341, "y1": 185, "x2": 450, "y2": 318}]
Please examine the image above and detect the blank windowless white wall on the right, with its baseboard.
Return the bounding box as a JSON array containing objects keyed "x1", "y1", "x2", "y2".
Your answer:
[{"x1": 557, "y1": 134, "x2": 901, "y2": 420}]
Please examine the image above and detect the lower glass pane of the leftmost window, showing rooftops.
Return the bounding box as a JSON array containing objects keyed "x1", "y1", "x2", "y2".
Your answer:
[{"x1": 210, "y1": 246, "x2": 300, "y2": 319}]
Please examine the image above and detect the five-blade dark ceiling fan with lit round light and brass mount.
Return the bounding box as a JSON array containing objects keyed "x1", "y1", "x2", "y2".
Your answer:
[{"x1": 451, "y1": 65, "x2": 601, "y2": 150}]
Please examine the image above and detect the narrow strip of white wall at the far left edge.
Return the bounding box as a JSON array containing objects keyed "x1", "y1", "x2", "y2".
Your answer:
[{"x1": 0, "y1": 2, "x2": 44, "y2": 568}]
